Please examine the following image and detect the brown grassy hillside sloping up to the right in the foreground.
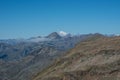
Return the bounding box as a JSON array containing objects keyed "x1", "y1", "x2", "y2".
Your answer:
[{"x1": 33, "y1": 37, "x2": 120, "y2": 80}]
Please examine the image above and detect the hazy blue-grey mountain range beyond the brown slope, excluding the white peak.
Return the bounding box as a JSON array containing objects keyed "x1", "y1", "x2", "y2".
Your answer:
[{"x1": 0, "y1": 32, "x2": 103, "y2": 80}]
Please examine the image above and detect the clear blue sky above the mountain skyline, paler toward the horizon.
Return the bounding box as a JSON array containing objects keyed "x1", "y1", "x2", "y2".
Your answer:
[{"x1": 0, "y1": 0, "x2": 120, "y2": 39}]
